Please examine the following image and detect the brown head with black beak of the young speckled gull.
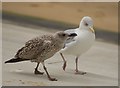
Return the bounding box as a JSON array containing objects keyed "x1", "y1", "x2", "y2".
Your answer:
[{"x1": 54, "y1": 31, "x2": 77, "y2": 41}]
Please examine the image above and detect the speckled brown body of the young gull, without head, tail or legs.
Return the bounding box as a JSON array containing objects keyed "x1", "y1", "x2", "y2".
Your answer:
[{"x1": 15, "y1": 35, "x2": 64, "y2": 62}]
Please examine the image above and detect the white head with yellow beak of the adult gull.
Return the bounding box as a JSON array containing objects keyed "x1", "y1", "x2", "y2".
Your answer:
[{"x1": 79, "y1": 16, "x2": 95, "y2": 33}]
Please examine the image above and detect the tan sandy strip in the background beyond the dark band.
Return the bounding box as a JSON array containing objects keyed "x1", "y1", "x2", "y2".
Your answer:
[{"x1": 3, "y1": 2, "x2": 118, "y2": 32}]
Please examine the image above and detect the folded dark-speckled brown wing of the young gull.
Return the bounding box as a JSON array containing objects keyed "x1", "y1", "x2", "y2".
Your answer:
[{"x1": 15, "y1": 37, "x2": 44, "y2": 59}]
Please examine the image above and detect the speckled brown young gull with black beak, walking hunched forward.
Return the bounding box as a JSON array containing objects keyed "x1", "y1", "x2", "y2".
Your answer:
[{"x1": 5, "y1": 31, "x2": 76, "y2": 81}]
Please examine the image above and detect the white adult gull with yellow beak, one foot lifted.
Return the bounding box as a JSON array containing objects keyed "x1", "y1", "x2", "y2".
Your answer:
[{"x1": 60, "y1": 16, "x2": 95, "y2": 75}]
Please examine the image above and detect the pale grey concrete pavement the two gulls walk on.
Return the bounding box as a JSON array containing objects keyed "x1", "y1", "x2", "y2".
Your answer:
[{"x1": 2, "y1": 22, "x2": 118, "y2": 86}]
